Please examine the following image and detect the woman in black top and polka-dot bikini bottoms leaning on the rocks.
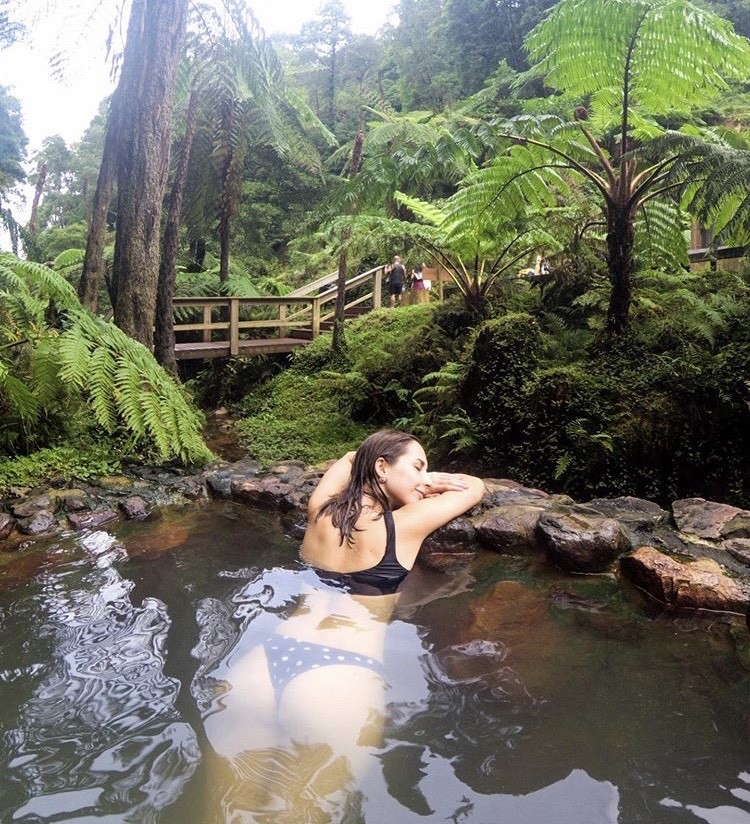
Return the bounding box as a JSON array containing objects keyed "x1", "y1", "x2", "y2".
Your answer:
[{"x1": 206, "y1": 430, "x2": 484, "y2": 822}]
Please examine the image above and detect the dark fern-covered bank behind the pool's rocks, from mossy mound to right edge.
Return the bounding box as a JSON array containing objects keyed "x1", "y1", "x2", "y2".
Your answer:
[{"x1": 240, "y1": 270, "x2": 750, "y2": 506}]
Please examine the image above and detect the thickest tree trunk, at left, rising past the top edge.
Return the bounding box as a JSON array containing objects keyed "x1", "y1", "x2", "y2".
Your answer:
[{"x1": 112, "y1": 0, "x2": 188, "y2": 347}]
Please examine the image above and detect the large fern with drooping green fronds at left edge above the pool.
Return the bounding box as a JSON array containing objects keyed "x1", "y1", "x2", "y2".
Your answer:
[{"x1": 0, "y1": 253, "x2": 211, "y2": 463}]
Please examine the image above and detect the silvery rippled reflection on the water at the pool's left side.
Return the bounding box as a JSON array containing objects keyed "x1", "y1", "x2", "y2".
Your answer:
[{"x1": 0, "y1": 564, "x2": 200, "y2": 822}]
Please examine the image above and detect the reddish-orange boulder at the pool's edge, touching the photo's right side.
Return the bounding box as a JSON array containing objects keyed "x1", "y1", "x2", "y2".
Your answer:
[{"x1": 620, "y1": 546, "x2": 749, "y2": 612}]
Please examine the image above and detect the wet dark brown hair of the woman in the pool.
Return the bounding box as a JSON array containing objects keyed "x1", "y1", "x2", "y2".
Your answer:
[{"x1": 316, "y1": 429, "x2": 424, "y2": 544}]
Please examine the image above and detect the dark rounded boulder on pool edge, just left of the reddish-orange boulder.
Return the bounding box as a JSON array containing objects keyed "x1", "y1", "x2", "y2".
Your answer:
[{"x1": 536, "y1": 510, "x2": 630, "y2": 572}]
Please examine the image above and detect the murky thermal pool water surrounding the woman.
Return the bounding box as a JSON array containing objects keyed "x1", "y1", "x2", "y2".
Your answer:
[{"x1": 0, "y1": 503, "x2": 750, "y2": 824}]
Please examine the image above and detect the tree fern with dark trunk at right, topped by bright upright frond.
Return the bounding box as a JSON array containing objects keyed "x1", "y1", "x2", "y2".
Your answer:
[{"x1": 488, "y1": 0, "x2": 750, "y2": 335}]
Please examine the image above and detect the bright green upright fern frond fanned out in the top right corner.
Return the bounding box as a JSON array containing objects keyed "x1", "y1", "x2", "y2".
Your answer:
[{"x1": 526, "y1": 0, "x2": 750, "y2": 120}]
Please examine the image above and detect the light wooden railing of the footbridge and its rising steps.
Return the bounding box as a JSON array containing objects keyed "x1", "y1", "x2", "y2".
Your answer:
[{"x1": 173, "y1": 266, "x2": 383, "y2": 359}]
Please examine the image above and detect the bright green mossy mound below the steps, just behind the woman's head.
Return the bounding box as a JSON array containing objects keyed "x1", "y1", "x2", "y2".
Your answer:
[{"x1": 239, "y1": 305, "x2": 452, "y2": 462}]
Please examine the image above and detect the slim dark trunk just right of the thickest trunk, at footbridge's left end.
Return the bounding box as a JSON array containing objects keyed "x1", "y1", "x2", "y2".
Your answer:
[{"x1": 154, "y1": 89, "x2": 198, "y2": 374}]
